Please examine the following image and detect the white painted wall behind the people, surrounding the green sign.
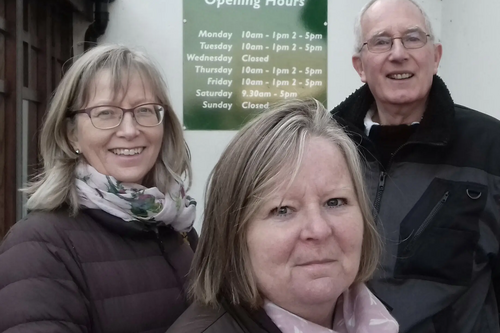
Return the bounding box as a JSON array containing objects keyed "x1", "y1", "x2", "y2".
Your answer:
[{"x1": 74, "y1": 0, "x2": 500, "y2": 230}]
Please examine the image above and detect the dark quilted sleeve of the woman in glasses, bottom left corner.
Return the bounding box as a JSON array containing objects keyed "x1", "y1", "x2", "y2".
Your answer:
[{"x1": 0, "y1": 214, "x2": 90, "y2": 333}]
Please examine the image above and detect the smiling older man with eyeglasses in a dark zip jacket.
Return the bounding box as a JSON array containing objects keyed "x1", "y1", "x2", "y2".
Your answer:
[{"x1": 332, "y1": 0, "x2": 500, "y2": 333}]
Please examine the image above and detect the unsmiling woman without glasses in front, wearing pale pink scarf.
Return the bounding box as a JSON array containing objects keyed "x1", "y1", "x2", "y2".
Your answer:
[{"x1": 168, "y1": 100, "x2": 398, "y2": 333}]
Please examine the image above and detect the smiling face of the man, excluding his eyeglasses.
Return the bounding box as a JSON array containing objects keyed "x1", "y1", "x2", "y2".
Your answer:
[{"x1": 352, "y1": 0, "x2": 442, "y2": 106}]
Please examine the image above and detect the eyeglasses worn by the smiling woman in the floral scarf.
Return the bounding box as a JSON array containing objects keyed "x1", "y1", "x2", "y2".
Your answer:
[{"x1": 73, "y1": 103, "x2": 165, "y2": 129}]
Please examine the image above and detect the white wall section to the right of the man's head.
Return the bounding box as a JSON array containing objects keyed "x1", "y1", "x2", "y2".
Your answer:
[{"x1": 440, "y1": 0, "x2": 500, "y2": 114}]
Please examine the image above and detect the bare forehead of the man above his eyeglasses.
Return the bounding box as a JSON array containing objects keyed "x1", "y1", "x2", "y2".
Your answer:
[{"x1": 361, "y1": 0, "x2": 426, "y2": 38}]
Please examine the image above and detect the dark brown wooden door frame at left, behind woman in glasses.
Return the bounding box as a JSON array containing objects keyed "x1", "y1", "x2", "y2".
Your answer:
[{"x1": 0, "y1": 0, "x2": 93, "y2": 239}]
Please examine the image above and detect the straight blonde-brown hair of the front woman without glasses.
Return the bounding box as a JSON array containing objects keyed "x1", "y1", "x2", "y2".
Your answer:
[{"x1": 190, "y1": 100, "x2": 381, "y2": 308}]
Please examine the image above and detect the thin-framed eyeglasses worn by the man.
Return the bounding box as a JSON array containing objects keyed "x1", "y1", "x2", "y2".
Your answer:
[{"x1": 359, "y1": 30, "x2": 430, "y2": 53}]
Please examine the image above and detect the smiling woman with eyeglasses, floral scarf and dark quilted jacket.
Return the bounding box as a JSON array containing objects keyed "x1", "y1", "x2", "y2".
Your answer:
[{"x1": 0, "y1": 46, "x2": 197, "y2": 333}]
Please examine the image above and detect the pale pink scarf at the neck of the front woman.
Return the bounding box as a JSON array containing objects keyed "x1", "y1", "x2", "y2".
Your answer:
[{"x1": 264, "y1": 283, "x2": 399, "y2": 333}]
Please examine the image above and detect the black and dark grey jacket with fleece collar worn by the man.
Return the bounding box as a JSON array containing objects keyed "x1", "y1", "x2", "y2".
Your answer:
[{"x1": 332, "y1": 76, "x2": 500, "y2": 333}]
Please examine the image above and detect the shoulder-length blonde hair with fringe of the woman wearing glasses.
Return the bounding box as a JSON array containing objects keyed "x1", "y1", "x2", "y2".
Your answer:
[{"x1": 23, "y1": 45, "x2": 191, "y2": 214}]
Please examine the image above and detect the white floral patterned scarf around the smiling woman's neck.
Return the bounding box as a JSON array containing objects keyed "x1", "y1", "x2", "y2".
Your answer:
[{"x1": 75, "y1": 162, "x2": 196, "y2": 232}]
